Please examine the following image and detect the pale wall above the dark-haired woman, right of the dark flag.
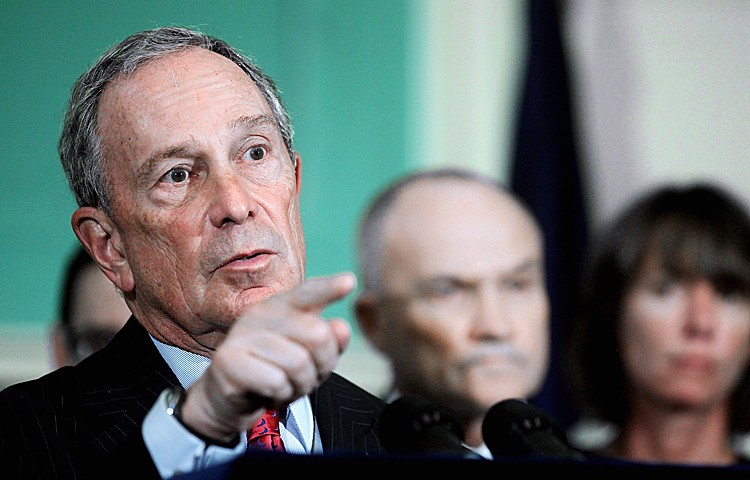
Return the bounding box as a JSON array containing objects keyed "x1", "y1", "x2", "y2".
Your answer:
[{"x1": 567, "y1": 0, "x2": 750, "y2": 228}]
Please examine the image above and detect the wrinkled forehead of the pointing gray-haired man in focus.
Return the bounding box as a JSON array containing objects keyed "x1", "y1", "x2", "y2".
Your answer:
[{"x1": 99, "y1": 47, "x2": 280, "y2": 162}]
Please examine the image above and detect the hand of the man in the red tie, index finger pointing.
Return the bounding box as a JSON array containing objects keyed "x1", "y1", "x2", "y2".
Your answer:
[{"x1": 176, "y1": 273, "x2": 356, "y2": 442}]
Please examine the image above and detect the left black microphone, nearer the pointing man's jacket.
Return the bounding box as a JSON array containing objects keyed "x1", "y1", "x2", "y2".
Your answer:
[{"x1": 378, "y1": 396, "x2": 484, "y2": 460}]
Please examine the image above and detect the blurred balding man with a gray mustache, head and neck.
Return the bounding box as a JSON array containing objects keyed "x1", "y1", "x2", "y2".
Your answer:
[{"x1": 355, "y1": 168, "x2": 549, "y2": 458}]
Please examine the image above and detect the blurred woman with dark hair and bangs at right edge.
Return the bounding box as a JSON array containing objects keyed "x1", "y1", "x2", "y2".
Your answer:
[{"x1": 566, "y1": 184, "x2": 750, "y2": 465}]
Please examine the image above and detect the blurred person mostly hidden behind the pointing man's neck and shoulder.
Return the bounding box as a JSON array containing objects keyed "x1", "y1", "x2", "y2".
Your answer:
[{"x1": 49, "y1": 245, "x2": 131, "y2": 368}]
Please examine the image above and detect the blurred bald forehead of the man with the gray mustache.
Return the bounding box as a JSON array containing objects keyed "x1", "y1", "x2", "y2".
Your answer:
[{"x1": 385, "y1": 181, "x2": 543, "y2": 275}]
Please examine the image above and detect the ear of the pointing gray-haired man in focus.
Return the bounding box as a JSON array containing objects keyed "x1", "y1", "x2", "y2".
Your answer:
[{"x1": 71, "y1": 207, "x2": 135, "y2": 293}]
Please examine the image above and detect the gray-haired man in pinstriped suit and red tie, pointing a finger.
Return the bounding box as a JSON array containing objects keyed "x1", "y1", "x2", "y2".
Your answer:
[{"x1": 0, "y1": 27, "x2": 385, "y2": 478}]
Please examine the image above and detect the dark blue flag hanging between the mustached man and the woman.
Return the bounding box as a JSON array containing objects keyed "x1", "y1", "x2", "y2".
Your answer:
[{"x1": 510, "y1": 0, "x2": 588, "y2": 427}]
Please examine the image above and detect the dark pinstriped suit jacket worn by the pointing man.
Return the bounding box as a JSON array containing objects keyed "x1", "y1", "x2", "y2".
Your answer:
[{"x1": 0, "y1": 317, "x2": 385, "y2": 480}]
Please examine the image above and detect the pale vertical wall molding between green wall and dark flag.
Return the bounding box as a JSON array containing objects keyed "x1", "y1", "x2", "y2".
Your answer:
[{"x1": 409, "y1": 0, "x2": 525, "y2": 181}]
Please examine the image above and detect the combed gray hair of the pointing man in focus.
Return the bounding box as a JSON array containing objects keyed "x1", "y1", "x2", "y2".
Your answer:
[{"x1": 58, "y1": 27, "x2": 294, "y2": 217}]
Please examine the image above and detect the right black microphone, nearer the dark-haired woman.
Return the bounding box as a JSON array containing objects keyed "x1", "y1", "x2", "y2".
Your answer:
[{"x1": 482, "y1": 399, "x2": 585, "y2": 460}]
